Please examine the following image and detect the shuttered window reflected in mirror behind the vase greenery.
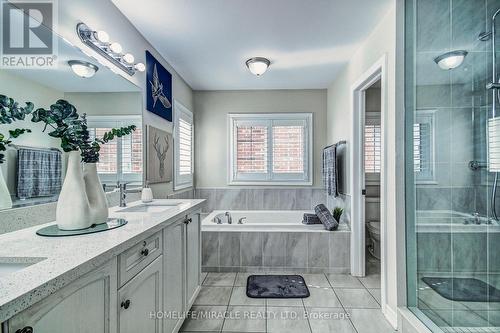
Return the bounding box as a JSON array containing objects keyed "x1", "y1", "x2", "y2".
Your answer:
[{"x1": 87, "y1": 116, "x2": 143, "y2": 184}]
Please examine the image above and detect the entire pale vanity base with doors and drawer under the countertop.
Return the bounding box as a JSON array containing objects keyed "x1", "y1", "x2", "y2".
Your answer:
[{"x1": 2, "y1": 211, "x2": 201, "y2": 333}]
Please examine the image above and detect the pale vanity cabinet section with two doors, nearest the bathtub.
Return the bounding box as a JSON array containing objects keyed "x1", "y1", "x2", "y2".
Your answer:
[{"x1": 163, "y1": 213, "x2": 201, "y2": 333}]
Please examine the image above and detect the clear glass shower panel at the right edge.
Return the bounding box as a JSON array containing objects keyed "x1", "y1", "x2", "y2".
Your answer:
[{"x1": 405, "y1": 0, "x2": 500, "y2": 332}]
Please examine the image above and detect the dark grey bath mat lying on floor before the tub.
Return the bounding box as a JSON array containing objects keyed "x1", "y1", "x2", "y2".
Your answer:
[{"x1": 247, "y1": 275, "x2": 310, "y2": 298}]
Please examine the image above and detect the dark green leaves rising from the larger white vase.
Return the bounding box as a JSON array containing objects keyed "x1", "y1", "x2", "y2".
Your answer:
[{"x1": 31, "y1": 99, "x2": 89, "y2": 152}]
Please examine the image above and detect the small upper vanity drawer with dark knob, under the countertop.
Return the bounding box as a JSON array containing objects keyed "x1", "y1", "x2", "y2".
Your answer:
[{"x1": 118, "y1": 232, "x2": 163, "y2": 286}]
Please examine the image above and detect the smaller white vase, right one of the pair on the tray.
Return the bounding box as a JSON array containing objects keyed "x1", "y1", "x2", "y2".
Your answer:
[{"x1": 83, "y1": 163, "x2": 109, "y2": 224}]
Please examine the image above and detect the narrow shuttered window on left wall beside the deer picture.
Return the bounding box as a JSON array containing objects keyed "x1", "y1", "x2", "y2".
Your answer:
[{"x1": 174, "y1": 101, "x2": 194, "y2": 190}]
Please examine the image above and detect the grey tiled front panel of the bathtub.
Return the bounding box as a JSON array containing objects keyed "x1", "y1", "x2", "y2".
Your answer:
[{"x1": 202, "y1": 229, "x2": 351, "y2": 273}]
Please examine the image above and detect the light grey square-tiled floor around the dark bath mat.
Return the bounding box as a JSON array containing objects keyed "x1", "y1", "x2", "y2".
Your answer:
[{"x1": 180, "y1": 272, "x2": 394, "y2": 333}]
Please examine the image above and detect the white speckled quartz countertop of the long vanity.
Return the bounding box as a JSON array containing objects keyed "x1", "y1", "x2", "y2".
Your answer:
[{"x1": 0, "y1": 199, "x2": 205, "y2": 322}]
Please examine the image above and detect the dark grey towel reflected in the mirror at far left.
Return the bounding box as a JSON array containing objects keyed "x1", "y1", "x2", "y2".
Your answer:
[{"x1": 17, "y1": 149, "x2": 62, "y2": 199}]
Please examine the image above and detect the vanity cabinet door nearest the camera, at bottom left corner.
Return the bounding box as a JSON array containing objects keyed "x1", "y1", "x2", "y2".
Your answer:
[{"x1": 4, "y1": 258, "x2": 118, "y2": 333}]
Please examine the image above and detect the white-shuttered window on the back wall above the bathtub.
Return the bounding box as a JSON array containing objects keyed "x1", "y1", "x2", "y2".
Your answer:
[{"x1": 229, "y1": 113, "x2": 312, "y2": 185}]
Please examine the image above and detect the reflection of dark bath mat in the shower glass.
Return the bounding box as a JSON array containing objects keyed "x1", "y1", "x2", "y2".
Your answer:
[{"x1": 422, "y1": 277, "x2": 500, "y2": 302}]
